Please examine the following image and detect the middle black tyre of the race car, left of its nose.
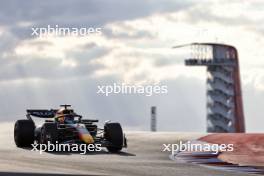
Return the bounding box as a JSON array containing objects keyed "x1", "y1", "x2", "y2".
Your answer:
[{"x1": 40, "y1": 123, "x2": 58, "y2": 144}]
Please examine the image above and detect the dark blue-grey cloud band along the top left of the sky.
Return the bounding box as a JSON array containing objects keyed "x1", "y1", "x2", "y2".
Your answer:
[{"x1": 0, "y1": 0, "x2": 190, "y2": 37}]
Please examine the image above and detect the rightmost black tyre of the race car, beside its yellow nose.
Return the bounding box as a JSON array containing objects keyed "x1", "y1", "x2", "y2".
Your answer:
[{"x1": 104, "y1": 123, "x2": 124, "y2": 153}]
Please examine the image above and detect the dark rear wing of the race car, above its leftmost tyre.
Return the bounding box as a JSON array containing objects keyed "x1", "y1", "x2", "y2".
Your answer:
[{"x1": 26, "y1": 109, "x2": 58, "y2": 120}]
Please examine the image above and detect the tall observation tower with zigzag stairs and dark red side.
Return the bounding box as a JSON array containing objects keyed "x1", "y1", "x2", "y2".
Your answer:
[{"x1": 185, "y1": 43, "x2": 245, "y2": 133}]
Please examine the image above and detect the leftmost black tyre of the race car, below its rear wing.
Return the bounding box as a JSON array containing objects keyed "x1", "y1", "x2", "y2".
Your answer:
[{"x1": 14, "y1": 120, "x2": 35, "y2": 147}]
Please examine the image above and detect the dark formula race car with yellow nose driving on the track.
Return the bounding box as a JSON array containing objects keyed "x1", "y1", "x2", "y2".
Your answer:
[{"x1": 14, "y1": 105, "x2": 127, "y2": 152}]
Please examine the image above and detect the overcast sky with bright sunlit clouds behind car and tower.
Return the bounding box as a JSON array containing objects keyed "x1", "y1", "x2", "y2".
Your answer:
[{"x1": 0, "y1": 0, "x2": 264, "y2": 132}]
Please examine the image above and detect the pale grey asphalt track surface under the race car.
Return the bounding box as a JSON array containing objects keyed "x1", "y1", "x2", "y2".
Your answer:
[{"x1": 0, "y1": 123, "x2": 256, "y2": 176}]
